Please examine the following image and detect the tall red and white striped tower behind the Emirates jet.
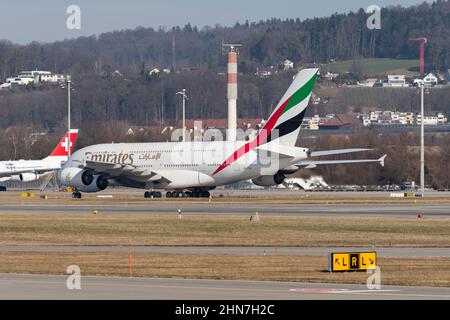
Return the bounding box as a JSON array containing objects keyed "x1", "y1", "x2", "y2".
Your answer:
[{"x1": 227, "y1": 48, "x2": 237, "y2": 141}]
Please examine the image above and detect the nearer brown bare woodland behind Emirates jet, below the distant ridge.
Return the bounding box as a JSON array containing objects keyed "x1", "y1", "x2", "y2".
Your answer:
[{"x1": 0, "y1": 70, "x2": 292, "y2": 131}]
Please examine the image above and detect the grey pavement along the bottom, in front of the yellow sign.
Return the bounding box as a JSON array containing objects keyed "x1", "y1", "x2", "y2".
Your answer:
[{"x1": 0, "y1": 274, "x2": 450, "y2": 300}]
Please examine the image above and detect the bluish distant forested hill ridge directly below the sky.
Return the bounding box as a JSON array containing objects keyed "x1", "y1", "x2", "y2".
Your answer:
[{"x1": 0, "y1": 0, "x2": 450, "y2": 77}]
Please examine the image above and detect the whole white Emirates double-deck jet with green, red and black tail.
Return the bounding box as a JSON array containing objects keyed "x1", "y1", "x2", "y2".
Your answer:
[{"x1": 59, "y1": 69, "x2": 385, "y2": 198}]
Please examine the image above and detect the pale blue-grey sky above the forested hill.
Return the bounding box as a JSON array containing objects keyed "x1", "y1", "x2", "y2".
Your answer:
[{"x1": 0, "y1": 0, "x2": 432, "y2": 44}]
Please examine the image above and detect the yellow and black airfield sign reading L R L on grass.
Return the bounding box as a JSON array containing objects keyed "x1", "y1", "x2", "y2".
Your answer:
[{"x1": 329, "y1": 252, "x2": 377, "y2": 272}]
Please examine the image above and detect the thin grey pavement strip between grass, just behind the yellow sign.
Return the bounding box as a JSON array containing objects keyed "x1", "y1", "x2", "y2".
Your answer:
[{"x1": 0, "y1": 246, "x2": 450, "y2": 258}]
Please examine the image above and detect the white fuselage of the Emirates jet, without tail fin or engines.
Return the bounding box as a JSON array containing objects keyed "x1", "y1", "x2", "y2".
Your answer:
[{"x1": 63, "y1": 141, "x2": 307, "y2": 189}]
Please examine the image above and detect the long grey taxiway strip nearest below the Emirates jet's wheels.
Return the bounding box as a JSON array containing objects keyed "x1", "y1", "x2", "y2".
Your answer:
[{"x1": 0, "y1": 200, "x2": 450, "y2": 218}]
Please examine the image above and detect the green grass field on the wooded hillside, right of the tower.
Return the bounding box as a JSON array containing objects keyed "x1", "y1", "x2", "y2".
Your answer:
[{"x1": 323, "y1": 59, "x2": 419, "y2": 75}]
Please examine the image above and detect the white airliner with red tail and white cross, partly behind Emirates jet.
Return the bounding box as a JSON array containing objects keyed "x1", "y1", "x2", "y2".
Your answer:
[{"x1": 0, "y1": 129, "x2": 78, "y2": 186}]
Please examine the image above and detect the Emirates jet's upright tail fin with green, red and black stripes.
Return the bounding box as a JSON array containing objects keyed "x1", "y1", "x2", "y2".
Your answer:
[{"x1": 263, "y1": 68, "x2": 319, "y2": 146}]
